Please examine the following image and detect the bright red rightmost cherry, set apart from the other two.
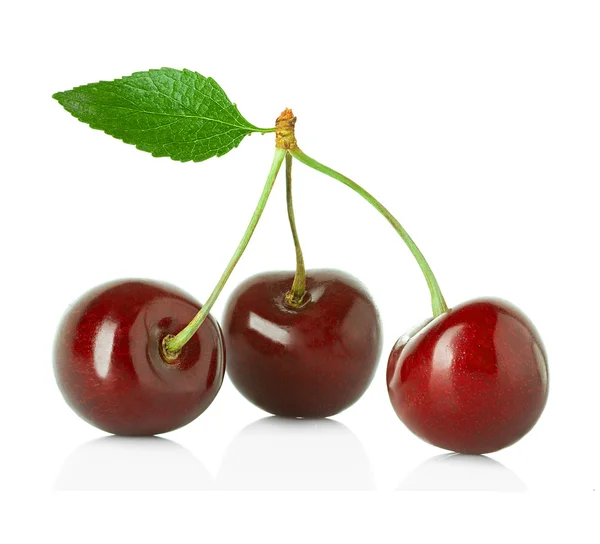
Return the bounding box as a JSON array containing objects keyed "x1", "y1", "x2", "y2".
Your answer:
[{"x1": 387, "y1": 299, "x2": 548, "y2": 454}]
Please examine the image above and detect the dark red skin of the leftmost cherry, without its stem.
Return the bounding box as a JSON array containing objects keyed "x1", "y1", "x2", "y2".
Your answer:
[{"x1": 54, "y1": 280, "x2": 225, "y2": 436}]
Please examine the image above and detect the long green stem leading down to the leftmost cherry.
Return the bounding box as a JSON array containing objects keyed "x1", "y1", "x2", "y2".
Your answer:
[{"x1": 162, "y1": 148, "x2": 286, "y2": 361}]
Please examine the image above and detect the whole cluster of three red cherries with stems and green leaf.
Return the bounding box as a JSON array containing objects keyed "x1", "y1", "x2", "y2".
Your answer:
[{"x1": 54, "y1": 68, "x2": 548, "y2": 454}]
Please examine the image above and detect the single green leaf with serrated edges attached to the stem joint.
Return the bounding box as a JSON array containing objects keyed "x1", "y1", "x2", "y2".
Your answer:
[{"x1": 53, "y1": 68, "x2": 275, "y2": 162}]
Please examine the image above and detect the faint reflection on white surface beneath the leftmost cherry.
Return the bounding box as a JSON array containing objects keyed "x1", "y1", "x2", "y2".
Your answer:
[{"x1": 54, "y1": 436, "x2": 213, "y2": 491}]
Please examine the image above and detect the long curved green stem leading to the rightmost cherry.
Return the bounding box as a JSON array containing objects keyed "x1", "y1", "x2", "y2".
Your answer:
[{"x1": 290, "y1": 147, "x2": 448, "y2": 317}]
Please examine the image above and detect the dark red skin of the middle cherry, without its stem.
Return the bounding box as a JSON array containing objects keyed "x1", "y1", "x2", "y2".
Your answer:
[{"x1": 223, "y1": 270, "x2": 381, "y2": 418}]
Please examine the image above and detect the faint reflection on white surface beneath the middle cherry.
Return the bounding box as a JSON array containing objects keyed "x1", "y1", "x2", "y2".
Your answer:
[{"x1": 217, "y1": 417, "x2": 374, "y2": 490}]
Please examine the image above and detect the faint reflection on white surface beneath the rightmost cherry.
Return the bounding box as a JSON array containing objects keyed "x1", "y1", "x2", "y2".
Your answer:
[{"x1": 398, "y1": 453, "x2": 527, "y2": 491}]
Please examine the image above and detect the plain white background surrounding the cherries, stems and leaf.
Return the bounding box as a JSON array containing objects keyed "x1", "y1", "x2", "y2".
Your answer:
[{"x1": 0, "y1": 0, "x2": 600, "y2": 542}]
